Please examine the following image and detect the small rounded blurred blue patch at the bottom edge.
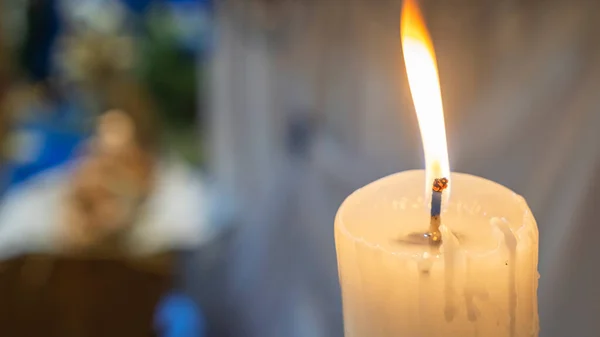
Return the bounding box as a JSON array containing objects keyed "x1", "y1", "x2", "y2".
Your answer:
[{"x1": 155, "y1": 293, "x2": 206, "y2": 337}]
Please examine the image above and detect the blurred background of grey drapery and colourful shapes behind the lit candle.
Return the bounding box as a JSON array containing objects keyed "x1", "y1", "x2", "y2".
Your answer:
[{"x1": 0, "y1": 0, "x2": 600, "y2": 337}]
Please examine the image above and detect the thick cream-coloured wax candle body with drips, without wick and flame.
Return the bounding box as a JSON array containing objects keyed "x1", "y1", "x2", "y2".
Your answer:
[{"x1": 335, "y1": 171, "x2": 539, "y2": 337}]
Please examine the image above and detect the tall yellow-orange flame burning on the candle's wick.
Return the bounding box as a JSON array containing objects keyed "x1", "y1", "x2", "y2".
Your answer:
[{"x1": 400, "y1": 0, "x2": 450, "y2": 195}]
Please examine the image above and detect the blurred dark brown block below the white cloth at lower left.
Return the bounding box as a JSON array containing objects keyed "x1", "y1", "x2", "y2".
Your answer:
[{"x1": 0, "y1": 254, "x2": 173, "y2": 337}]
